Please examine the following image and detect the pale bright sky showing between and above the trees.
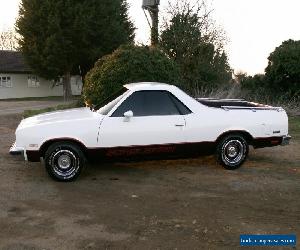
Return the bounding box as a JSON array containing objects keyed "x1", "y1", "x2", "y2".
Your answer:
[{"x1": 0, "y1": 0, "x2": 300, "y2": 75}]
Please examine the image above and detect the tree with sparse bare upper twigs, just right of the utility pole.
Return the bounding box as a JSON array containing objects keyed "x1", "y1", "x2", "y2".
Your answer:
[{"x1": 160, "y1": 2, "x2": 232, "y2": 92}]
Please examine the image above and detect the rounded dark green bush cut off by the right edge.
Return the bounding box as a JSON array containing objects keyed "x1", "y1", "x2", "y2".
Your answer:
[{"x1": 265, "y1": 40, "x2": 300, "y2": 94}]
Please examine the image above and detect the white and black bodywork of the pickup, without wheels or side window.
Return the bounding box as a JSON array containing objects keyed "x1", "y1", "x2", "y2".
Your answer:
[{"x1": 10, "y1": 83, "x2": 290, "y2": 161}]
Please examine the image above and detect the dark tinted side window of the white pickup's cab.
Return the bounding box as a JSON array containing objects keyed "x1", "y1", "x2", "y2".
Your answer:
[{"x1": 112, "y1": 90, "x2": 180, "y2": 117}]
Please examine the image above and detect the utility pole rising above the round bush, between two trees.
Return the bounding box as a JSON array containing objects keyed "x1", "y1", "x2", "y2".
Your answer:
[{"x1": 142, "y1": 0, "x2": 160, "y2": 47}]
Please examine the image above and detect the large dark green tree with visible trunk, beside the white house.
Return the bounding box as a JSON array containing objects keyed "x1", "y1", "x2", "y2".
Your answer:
[{"x1": 16, "y1": 0, "x2": 134, "y2": 99}]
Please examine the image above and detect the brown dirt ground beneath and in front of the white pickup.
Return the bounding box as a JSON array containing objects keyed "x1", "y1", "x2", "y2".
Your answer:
[{"x1": 0, "y1": 115, "x2": 300, "y2": 250}]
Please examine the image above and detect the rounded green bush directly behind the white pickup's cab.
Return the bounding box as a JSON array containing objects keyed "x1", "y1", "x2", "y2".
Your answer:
[{"x1": 83, "y1": 46, "x2": 179, "y2": 104}]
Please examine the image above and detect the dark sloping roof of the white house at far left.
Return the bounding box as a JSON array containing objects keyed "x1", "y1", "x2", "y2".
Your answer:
[{"x1": 0, "y1": 50, "x2": 32, "y2": 73}]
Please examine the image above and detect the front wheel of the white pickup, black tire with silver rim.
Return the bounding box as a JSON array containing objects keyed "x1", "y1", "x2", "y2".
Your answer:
[{"x1": 45, "y1": 142, "x2": 85, "y2": 182}]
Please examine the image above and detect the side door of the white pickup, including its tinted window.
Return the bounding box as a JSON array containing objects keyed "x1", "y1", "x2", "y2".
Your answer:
[{"x1": 98, "y1": 90, "x2": 185, "y2": 154}]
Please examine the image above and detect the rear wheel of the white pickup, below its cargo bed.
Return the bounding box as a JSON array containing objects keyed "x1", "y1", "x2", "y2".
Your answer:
[{"x1": 216, "y1": 134, "x2": 249, "y2": 170}]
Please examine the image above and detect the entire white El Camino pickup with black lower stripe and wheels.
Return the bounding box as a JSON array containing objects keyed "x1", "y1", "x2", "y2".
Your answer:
[{"x1": 10, "y1": 83, "x2": 290, "y2": 181}]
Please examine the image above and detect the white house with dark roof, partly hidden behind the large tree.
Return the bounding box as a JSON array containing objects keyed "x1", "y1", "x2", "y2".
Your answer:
[{"x1": 0, "y1": 50, "x2": 82, "y2": 99}]
